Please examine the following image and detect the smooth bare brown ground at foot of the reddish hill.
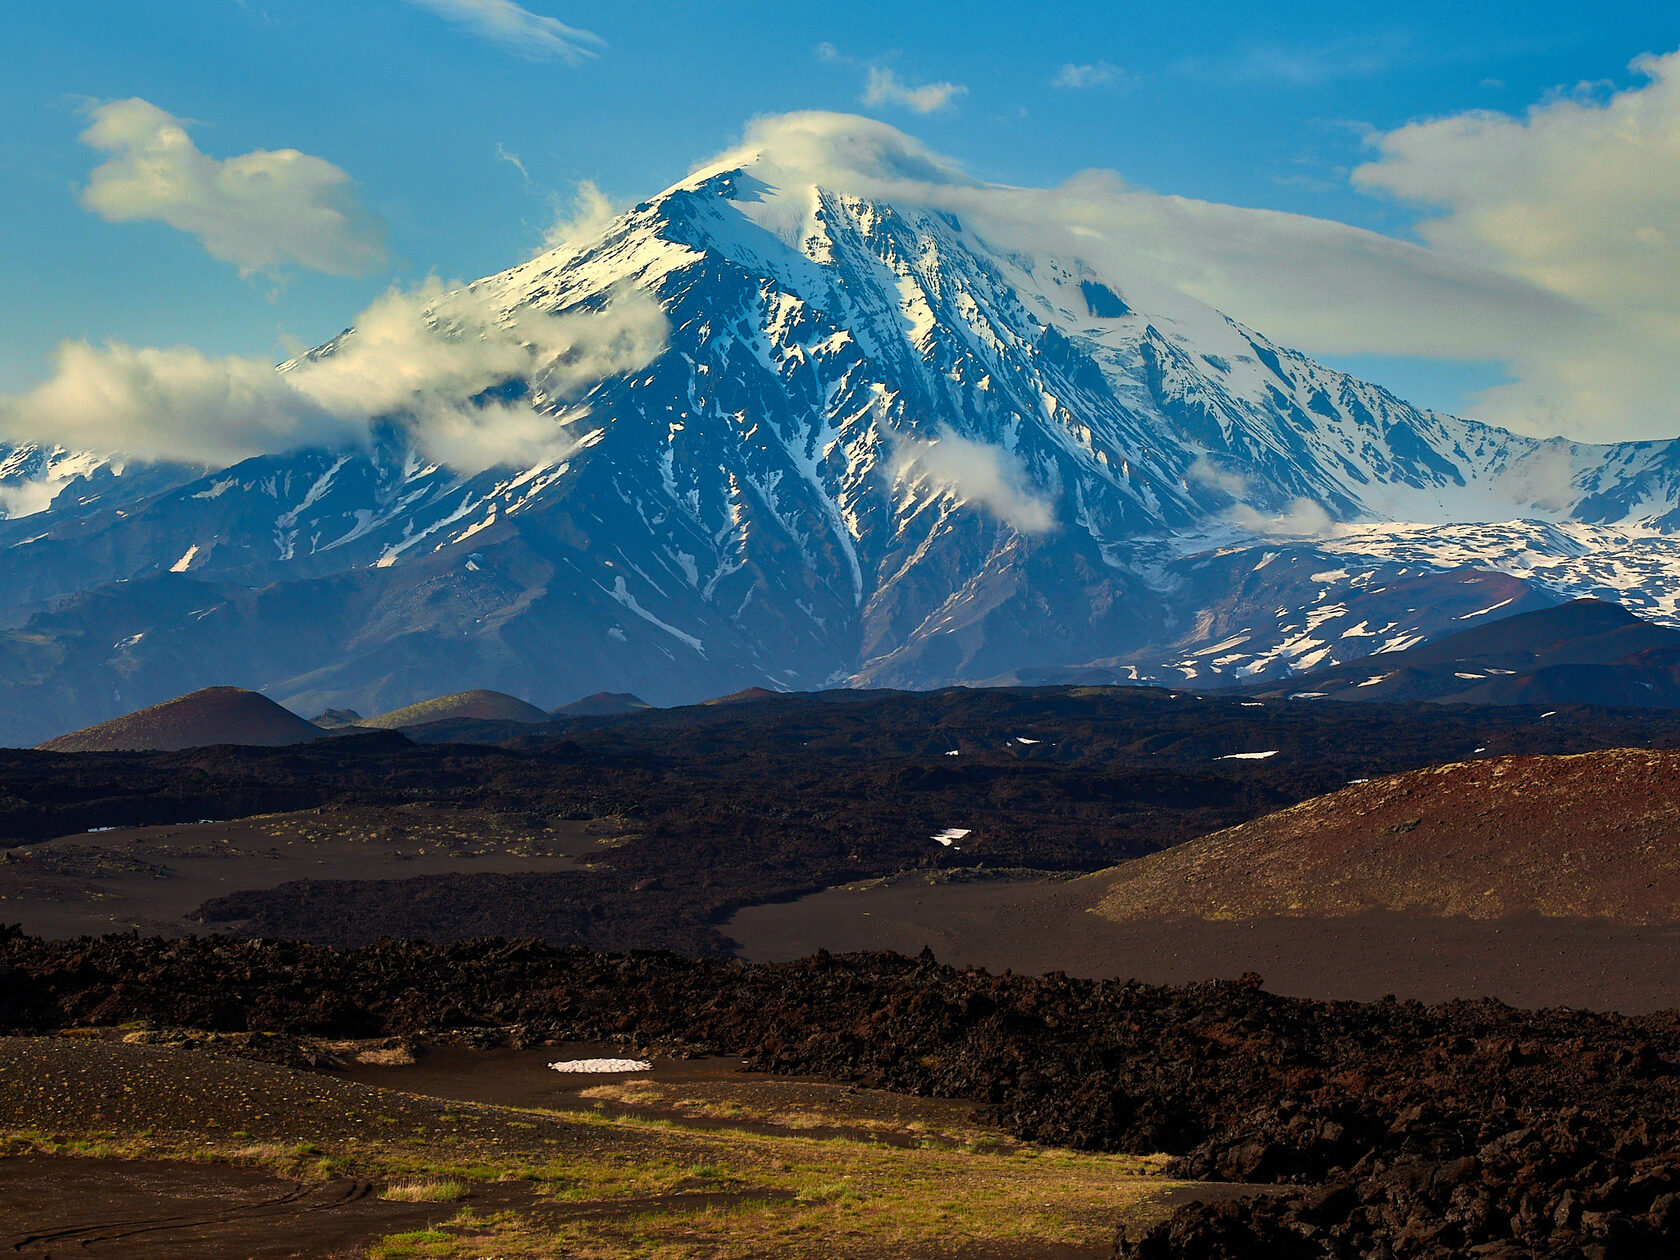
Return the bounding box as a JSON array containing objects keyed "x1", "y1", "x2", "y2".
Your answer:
[{"x1": 722, "y1": 872, "x2": 1680, "y2": 1015}]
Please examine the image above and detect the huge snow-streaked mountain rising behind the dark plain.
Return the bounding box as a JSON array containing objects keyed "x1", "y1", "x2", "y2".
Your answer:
[{"x1": 0, "y1": 136, "x2": 1680, "y2": 743}]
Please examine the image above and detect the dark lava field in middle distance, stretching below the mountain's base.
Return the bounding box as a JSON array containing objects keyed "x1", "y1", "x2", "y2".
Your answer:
[{"x1": 16, "y1": 687, "x2": 1680, "y2": 954}]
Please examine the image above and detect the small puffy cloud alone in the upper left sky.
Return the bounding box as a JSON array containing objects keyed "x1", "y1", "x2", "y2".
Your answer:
[{"x1": 81, "y1": 97, "x2": 385, "y2": 276}]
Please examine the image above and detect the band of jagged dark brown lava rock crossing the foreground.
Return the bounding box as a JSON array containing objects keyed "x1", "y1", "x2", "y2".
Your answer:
[{"x1": 0, "y1": 936, "x2": 1680, "y2": 1260}]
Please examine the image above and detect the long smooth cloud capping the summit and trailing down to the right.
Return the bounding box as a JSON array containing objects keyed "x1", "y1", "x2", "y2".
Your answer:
[{"x1": 705, "y1": 108, "x2": 1680, "y2": 440}]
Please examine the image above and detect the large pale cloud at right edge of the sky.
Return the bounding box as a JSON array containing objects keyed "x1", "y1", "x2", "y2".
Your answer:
[{"x1": 1352, "y1": 52, "x2": 1680, "y2": 435}]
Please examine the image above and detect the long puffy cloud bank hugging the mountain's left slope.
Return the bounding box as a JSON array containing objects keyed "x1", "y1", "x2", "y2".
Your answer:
[{"x1": 0, "y1": 281, "x2": 669, "y2": 472}]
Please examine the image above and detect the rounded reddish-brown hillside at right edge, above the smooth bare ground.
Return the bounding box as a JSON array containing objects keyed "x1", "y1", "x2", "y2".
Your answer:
[{"x1": 1082, "y1": 749, "x2": 1680, "y2": 924}]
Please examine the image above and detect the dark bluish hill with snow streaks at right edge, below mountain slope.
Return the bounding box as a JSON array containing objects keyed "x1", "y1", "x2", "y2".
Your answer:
[{"x1": 1255, "y1": 600, "x2": 1680, "y2": 709}]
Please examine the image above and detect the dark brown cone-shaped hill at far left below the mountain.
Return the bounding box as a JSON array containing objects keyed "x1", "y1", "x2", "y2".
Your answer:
[{"x1": 40, "y1": 687, "x2": 326, "y2": 753}]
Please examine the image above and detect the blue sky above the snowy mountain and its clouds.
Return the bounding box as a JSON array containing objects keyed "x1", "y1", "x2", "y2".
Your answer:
[{"x1": 0, "y1": 0, "x2": 1680, "y2": 437}]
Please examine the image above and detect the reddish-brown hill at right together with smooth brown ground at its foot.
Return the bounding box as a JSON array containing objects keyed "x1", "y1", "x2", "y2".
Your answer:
[{"x1": 724, "y1": 751, "x2": 1680, "y2": 1013}]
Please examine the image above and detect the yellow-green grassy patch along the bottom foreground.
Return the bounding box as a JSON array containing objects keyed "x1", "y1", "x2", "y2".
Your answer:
[{"x1": 8, "y1": 1104, "x2": 1173, "y2": 1260}]
